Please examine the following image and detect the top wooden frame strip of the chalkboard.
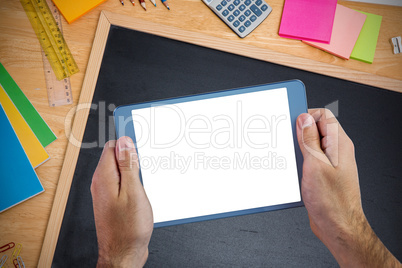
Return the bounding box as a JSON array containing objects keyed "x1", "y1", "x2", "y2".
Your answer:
[{"x1": 104, "y1": 11, "x2": 402, "y2": 92}]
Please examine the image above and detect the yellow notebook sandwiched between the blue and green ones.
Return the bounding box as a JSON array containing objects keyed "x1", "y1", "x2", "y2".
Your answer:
[{"x1": 0, "y1": 84, "x2": 49, "y2": 168}]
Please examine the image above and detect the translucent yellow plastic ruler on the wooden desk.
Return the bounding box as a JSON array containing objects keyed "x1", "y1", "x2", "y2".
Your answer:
[{"x1": 20, "y1": 0, "x2": 79, "y2": 80}]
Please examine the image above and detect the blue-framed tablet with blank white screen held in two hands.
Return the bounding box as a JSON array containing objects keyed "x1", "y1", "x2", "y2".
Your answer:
[{"x1": 114, "y1": 80, "x2": 307, "y2": 227}]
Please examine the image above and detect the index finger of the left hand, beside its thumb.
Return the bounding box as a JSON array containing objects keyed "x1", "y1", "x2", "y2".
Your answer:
[{"x1": 91, "y1": 141, "x2": 120, "y2": 197}]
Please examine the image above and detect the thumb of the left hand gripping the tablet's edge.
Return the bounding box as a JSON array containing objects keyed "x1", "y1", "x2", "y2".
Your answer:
[{"x1": 116, "y1": 137, "x2": 143, "y2": 195}]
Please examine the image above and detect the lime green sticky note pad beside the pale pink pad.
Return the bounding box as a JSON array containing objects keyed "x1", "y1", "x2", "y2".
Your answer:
[{"x1": 350, "y1": 10, "x2": 382, "y2": 63}]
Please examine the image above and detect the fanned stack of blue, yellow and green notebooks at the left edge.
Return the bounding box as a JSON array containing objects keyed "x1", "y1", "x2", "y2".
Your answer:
[{"x1": 0, "y1": 63, "x2": 56, "y2": 212}]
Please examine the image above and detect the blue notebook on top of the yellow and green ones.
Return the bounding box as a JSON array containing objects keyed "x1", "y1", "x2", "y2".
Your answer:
[{"x1": 0, "y1": 104, "x2": 44, "y2": 212}]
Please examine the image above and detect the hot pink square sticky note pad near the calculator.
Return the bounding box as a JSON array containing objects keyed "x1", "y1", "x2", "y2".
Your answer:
[{"x1": 279, "y1": 0, "x2": 337, "y2": 44}]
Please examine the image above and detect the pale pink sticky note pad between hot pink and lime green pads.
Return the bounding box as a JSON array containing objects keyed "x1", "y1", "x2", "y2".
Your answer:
[{"x1": 303, "y1": 5, "x2": 367, "y2": 60}]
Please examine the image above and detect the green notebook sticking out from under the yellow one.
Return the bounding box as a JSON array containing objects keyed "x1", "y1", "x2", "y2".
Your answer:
[{"x1": 0, "y1": 63, "x2": 57, "y2": 147}]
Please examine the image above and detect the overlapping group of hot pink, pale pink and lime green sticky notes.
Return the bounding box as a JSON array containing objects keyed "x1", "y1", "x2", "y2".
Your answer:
[{"x1": 279, "y1": 0, "x2": 382, "y2": 63}]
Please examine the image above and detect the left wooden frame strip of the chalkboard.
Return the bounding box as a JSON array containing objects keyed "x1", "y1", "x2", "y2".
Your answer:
[{"x1": 38, "y1": 11, "x2": 110, "y2": 267}]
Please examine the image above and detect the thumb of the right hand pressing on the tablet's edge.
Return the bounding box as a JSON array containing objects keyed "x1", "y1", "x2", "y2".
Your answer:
[{"x1": 297, "y1": 113, "x2": 331, "y2": 165}]
